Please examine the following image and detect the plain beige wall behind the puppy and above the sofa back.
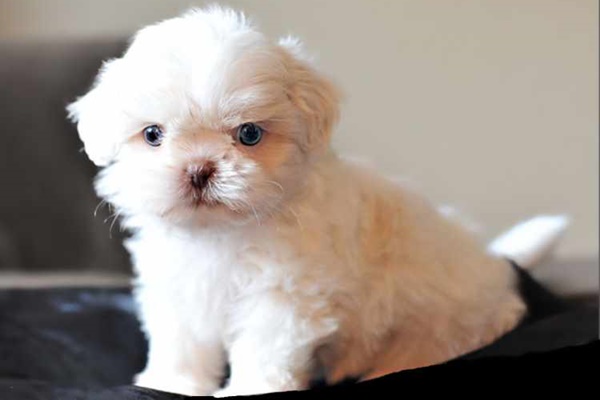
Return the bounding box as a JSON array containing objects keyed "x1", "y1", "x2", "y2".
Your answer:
[{"x1": 0, "y1": 0, "x2": 598, "y2": 257}]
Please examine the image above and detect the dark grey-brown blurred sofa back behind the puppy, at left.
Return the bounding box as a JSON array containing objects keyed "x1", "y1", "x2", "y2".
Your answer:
[{"x1": 0, "y1": 41, "x2": 129, "y2": 271}]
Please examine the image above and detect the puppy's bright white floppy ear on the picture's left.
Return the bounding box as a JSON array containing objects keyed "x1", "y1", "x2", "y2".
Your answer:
[{"x1": 67, "y1": 60, "x2": 125, "y2": 167}]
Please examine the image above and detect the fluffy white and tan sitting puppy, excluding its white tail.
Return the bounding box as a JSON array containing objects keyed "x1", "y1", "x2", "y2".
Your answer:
[{"x1": 68, "y1": 7, "x2": 564, "y2": 396}]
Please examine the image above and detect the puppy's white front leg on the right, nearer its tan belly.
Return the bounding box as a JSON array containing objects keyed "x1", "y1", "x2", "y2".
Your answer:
[{"x1": 214, "y1": 295, "x2": 337, "y2": 397}]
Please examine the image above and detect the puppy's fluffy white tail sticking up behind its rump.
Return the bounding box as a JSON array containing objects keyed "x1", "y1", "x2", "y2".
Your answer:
[{"x1": 488, "y1": 215, "x2": 569, "y2": 269}]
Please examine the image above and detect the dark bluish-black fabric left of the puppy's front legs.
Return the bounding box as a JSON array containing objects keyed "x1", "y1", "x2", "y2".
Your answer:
[{"x1": 0, "y1": 289, "x2": 146, "y2": 390}]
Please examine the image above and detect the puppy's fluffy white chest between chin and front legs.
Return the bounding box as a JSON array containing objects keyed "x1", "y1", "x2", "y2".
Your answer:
[{"x1": 128, "y1": 228, "x2": 314, "y2": 321}]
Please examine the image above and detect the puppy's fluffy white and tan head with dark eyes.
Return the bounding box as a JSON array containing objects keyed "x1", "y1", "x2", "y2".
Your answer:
[{"x1": 68, "y1": 8, "x2": 338, "y2": 227}]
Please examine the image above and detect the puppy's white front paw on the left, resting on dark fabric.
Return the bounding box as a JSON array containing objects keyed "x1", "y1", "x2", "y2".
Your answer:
[{"x1": 134, "y1": 372, "x2": 218, "y2": 396}]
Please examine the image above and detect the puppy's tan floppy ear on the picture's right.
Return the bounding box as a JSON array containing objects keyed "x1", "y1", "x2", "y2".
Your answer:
[{"x1": 279, "y1": 37, "x2": 341, "y2": 150}]
